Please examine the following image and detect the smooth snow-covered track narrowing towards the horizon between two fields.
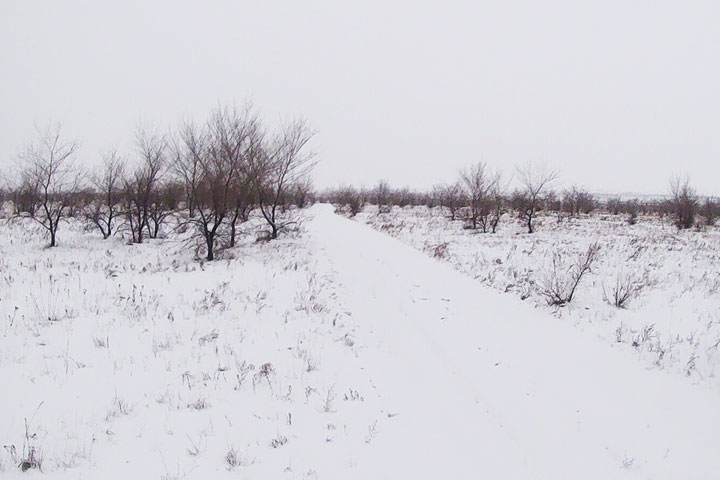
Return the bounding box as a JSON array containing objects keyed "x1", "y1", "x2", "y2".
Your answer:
[{"x1": 308, "y1": 205, "x2": 720, "y2": 479}]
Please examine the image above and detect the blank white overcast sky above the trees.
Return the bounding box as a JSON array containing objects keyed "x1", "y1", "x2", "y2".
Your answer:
[{"x1": 0, "y1": 0, "x2": 720, "y2": 195}]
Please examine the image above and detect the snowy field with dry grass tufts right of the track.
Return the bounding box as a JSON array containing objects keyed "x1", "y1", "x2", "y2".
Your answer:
[{"x1": 358, "y1": 207, "x2": 720, "y2": 388}]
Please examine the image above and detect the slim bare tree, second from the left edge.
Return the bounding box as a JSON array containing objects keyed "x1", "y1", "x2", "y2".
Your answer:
[{"x1": 85, "y1": 150, "x2": 125, "y2": 239}]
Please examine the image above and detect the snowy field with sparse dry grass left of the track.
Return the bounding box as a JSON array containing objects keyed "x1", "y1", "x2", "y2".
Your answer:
[{"x1": 0, "y1": 215, "x2": 387, "y2": 479}]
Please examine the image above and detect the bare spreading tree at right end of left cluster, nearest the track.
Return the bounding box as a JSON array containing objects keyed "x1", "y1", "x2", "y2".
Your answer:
[{"x1": 248, "y1": 120, "x2": 315, "y2": 239}]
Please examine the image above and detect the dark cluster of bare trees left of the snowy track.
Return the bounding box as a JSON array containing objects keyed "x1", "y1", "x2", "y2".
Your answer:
[{"x1": 2, "y1": 104, "x2": 314, "y2": 260}]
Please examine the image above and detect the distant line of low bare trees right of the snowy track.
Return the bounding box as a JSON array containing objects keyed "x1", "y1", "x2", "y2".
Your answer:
[{"x1": 318, "y1": 162, "x2": 720, "y2": 233}]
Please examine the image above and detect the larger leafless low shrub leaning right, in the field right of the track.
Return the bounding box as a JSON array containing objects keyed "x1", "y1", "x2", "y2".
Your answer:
[{"x1": 539, "y1": 242, "x2": 600, "y2": 306}]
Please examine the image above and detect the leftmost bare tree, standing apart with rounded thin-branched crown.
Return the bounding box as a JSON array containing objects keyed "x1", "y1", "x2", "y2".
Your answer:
[{"x1": 20, "y1": 125, "x2": 79, "y2": 247}]
